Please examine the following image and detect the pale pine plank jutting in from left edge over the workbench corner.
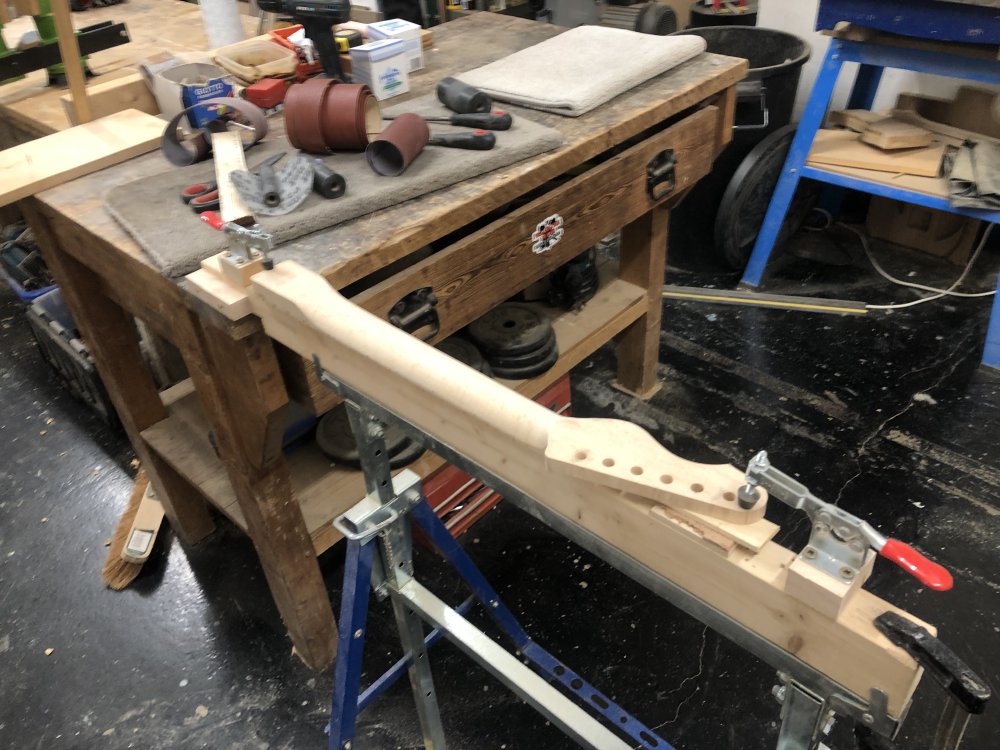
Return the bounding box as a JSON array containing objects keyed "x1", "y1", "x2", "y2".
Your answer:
[{"x1": 0, "y1": 109, "x2": 164, "y2": 206}]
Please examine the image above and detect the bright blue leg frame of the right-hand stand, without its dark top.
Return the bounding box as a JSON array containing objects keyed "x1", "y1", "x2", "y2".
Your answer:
[{"x1": 740, "y1": 33, "x2": 1000, "y2": 368}]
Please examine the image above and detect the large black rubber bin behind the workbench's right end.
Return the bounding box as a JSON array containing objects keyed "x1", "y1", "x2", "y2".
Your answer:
[{"x1": 670, "y1": 26, "x2": 811, "y2": 269}]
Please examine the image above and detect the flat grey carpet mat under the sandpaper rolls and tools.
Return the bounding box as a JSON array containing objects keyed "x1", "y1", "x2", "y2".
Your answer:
[{"x1": 105, "y1": 96, "x2": 563, "y2": 278}]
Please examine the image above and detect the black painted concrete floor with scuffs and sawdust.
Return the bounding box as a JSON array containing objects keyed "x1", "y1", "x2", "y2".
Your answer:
[{"x1": 0, "y1": 226, "x2": 1000, "y2": 750}]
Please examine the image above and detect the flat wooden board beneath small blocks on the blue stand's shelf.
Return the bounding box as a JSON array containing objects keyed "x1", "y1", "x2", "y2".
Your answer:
[{"x1": 807, "y1": 130, "x2": 945, "y2": 177}]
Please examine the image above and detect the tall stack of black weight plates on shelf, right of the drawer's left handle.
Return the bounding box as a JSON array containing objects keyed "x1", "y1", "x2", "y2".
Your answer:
[{"x1": 466, "y1": 302, "x2": 559, "y2": 380}]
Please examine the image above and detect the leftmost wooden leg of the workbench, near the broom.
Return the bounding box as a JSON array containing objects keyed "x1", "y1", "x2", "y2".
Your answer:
[{"x1": 22, "y1": 202, "x2": 215, "y2": 544}]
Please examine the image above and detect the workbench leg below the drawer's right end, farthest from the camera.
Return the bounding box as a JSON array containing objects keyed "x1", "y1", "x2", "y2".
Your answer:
[{"x1": 616, "y1": 207, "x2": 670, "y2": 398}]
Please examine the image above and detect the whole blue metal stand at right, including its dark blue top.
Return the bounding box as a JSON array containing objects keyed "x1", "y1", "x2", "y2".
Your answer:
[{"x1": 741, "y1": 0, "x2": 1000, "y2": 368}]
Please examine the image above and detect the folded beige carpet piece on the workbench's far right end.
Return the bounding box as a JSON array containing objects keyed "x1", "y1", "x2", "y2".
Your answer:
[{"x1": 455, "y1": 26, "x2": 705, "y2": 117}]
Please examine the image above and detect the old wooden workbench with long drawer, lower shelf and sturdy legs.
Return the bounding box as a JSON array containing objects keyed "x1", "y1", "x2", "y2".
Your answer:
[{"x1": 19, "y1": 13, "x2": 746, "y2": 668}]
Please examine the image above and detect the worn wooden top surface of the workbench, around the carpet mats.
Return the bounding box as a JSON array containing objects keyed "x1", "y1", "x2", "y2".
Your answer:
[{"x1": 31, "y1": 13, "x2": 746, "y2": 294}]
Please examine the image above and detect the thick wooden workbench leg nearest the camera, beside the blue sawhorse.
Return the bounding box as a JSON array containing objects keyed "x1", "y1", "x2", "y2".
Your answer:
[{"x1": 185, "y1": 322, "x2": 337, "y2": 669}]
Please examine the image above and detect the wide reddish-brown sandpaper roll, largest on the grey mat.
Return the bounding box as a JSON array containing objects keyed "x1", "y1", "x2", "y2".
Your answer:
[{"x1": 285, "y1": 78, "x2": 382, "y2": 154}]
